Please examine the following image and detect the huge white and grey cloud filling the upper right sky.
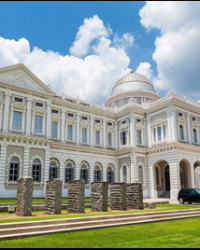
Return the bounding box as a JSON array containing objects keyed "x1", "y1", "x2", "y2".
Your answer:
[{"x1": 139, "y1": 1, "x2": 200, "y2": 96}]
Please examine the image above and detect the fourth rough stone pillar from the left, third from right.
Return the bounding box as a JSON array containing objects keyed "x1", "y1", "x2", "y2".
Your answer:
[{"x1": 91, "y1": 182, "x2": 108, "y2": 212}]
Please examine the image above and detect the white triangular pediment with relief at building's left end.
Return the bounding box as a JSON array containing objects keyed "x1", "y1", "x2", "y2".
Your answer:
[{"x1": 0, "y1": 64, "x2": 54, "y2": 94}]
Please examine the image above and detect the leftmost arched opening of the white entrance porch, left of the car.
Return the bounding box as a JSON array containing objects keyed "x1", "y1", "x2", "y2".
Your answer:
[{"x1": 154, "y1": 160, "x2": 171, "y2": 198}]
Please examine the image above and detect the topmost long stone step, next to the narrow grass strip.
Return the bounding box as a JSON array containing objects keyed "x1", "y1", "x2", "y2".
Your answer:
[{"x1": 0, "y1": 209, "x2": 200, "y2": 231}]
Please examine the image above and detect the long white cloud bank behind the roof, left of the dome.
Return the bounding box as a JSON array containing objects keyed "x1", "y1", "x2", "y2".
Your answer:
[{"x1": 0, "y1": 16, "x2": 134, "y2": 104}]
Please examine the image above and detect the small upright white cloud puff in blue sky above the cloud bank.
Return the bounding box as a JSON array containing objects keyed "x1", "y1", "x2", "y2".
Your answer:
[{"x1": 70, "y1": 15, "x2": 112, "y2": 56}]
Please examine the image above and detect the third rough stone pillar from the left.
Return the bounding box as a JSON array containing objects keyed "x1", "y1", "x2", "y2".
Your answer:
[{"x1": 67, "y1": 180, "x2": 85, "y2": 213}]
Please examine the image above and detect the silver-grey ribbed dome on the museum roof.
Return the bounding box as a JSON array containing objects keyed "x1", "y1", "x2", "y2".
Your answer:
[{"x1": 110, "y1": 72, "x2": 156, "y2": 96}]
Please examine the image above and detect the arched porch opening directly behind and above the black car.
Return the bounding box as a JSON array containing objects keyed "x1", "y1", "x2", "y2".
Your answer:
[{"x1": 179, "y1": 159, "x2": 191, "y2": 188}]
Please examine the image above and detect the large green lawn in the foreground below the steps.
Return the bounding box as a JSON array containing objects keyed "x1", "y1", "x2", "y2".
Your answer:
[{"x1": 0, "y1": 217, "x2": 200, "y2": 248}]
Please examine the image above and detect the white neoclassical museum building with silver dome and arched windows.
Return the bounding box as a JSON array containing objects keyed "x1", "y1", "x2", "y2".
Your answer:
[{"x1": 0, "y1": 64, "x2": 200, "y2": 199}]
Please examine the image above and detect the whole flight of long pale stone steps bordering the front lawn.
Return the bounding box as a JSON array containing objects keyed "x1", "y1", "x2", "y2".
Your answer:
[{"x1": 0, "y1": 209, "x2": 200, "y2": 239}]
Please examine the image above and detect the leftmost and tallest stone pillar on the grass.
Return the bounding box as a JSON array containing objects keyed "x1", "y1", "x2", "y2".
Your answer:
[{"x1": 16, "y1": 177, "x2": 33, "y2": 216}]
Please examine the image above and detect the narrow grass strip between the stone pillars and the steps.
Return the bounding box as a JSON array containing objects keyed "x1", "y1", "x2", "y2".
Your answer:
[{"x1": 0, "y1": 204, "x2": 200, "y2": 225}]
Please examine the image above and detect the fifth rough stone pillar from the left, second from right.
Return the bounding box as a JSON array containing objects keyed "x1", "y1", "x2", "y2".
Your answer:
[{"x1": 110, "y1": 182, "x2": 126, "y2": 210}]
